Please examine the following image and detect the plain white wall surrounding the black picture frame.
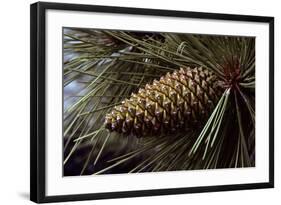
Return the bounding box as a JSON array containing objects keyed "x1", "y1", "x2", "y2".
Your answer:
[{"x1": 0, "y1": 0, "x2": 281, "y2": 205}]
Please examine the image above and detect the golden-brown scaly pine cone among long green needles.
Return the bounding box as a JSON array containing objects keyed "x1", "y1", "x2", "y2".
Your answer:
[{"x1": 105, "y1": 68, "x2": 222, "y2": 137}]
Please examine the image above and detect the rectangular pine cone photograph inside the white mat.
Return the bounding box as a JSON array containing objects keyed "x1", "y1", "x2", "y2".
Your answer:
[{"x1": 62, "y1": 27, "x2": 256, "y2": 177}]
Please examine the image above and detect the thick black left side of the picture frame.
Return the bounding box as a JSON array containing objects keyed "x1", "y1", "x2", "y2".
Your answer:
[{"x1": 30, "y1": 2, "x2": 46, "y2": 203}]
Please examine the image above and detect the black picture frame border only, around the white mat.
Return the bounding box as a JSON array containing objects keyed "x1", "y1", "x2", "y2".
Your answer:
[{"x1": 30, "y1": 2, "x2": 274, "y2": 203}]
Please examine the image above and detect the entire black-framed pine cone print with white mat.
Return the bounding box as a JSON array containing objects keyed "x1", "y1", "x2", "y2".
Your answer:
[{"x1": 30, "y1": 2, "x2": 274, "y2": 203}]
